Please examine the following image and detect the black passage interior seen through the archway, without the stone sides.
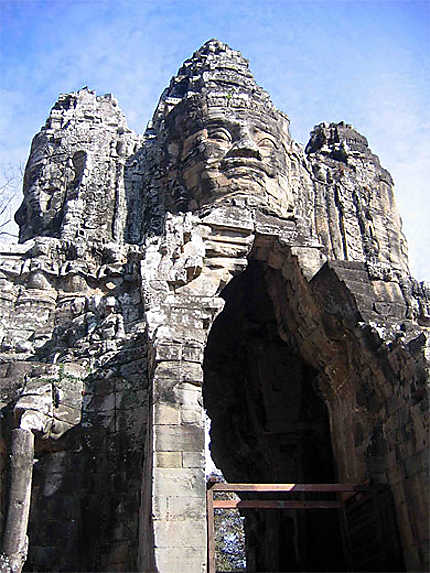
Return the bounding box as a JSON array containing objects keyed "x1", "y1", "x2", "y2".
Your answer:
[{"x1": 203, "y1": 261, "x2": 346, "y2": 571}]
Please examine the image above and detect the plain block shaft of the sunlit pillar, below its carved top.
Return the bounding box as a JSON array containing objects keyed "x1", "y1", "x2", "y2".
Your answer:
[{"x1": 152, "y1": 328, "x2": 206, "y2": 573}]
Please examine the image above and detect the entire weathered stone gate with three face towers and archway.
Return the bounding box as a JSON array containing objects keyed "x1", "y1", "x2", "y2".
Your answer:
[{"x1": 0, "y1": 40, "x2": 430, "y2": 573}]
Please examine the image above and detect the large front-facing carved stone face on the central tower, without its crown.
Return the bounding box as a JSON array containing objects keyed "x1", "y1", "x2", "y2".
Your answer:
[{"x1": 166, "y1": 98, "x2": 292, "y2": 215}]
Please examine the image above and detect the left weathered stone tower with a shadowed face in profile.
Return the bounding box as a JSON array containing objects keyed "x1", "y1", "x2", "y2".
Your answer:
[{"x1": 16, "y1": 88, "x2": 139, "y2": 242}]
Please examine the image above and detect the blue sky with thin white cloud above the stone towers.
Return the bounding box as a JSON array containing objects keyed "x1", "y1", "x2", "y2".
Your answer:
[{"x1": 0, "y1": 0, "x2": 430, "y2": 280}]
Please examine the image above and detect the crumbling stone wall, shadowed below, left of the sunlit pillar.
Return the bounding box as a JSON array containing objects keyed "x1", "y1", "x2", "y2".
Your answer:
[{"x1": 1, "y1": 238, "x2": 149, "y2": 571}]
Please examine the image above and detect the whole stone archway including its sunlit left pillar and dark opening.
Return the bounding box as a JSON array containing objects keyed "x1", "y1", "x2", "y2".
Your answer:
[{"x1": 139, "y1": 211, "x2": 424, "y2": 573}]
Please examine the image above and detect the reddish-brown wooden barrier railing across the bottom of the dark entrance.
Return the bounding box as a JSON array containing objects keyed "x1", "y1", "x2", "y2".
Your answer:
[{"x1": 206, "y1": 482, "x2": 368, "y2": 573}]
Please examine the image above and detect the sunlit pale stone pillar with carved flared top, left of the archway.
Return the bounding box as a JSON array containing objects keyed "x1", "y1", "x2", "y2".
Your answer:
[{"x1": 139, "y1": 212, "x2": 245, "y2": 573}]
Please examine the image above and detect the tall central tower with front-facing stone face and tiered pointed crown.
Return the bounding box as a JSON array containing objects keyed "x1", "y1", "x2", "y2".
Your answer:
[{"x1": 144, "y1": 40, "x2": 295, "y2": 218}]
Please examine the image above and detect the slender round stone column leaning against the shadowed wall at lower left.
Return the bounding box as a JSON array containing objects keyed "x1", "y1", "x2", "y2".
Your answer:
[{"x1": 3, "y1": 428, "x2": 34, "y2": 573}]
